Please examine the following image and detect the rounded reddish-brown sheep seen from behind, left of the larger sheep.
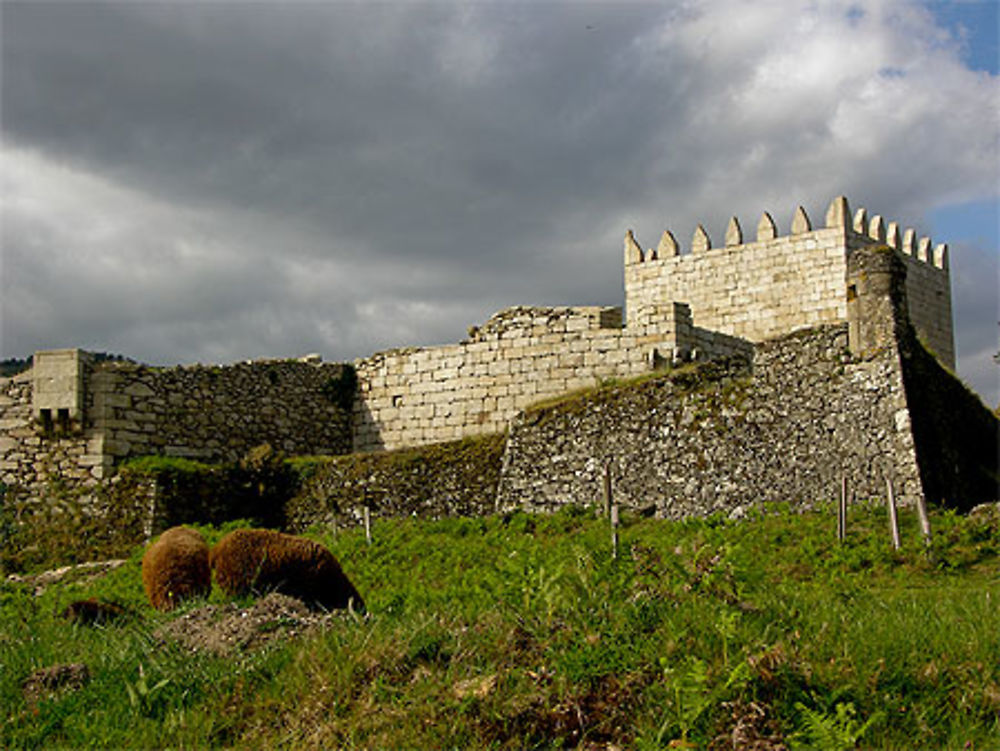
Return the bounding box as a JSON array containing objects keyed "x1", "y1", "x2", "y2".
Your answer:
[{"x1": 142, "y1": 527, "x2": 212, "y2": 610}]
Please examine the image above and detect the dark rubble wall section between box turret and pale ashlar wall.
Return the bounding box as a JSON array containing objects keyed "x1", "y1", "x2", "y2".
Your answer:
[{"x1": 89, "y1": 360, "x2": 350, "y2": 463}]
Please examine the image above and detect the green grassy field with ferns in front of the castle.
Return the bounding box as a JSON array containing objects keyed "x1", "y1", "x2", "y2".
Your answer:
[{"x1": 0, "y1": 502, "x2": 1000, "y2": 749}]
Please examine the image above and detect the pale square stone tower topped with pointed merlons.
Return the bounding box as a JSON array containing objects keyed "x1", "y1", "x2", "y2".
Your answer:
[{"x1": 625, "y1": 196, "x2": 955, "y2": 368}]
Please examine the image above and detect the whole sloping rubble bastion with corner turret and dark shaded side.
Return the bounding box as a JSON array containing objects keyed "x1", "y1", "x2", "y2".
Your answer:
[{"x1": 497, "y1": 247, "x2": 1000, "y2": 518}]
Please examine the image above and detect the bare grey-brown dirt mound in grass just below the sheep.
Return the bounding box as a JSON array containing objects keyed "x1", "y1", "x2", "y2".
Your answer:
[{"x1": 156, "y1": 592, "x2": 351, "y2": 655}]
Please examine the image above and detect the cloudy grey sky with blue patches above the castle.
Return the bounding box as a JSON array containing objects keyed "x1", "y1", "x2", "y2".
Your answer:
[{"x1": 0, "y1": 0, "x2": 1000, "y2": 405}]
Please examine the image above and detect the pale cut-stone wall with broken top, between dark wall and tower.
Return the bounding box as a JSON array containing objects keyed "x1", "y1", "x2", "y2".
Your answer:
[{"x1": 354, "y1": 303, "x2": 751, "y2": 451}]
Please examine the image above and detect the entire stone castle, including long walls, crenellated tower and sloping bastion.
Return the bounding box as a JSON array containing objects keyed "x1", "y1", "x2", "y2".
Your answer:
[{"x1": 0, "y1": 197, "x2": 997, "y2": 516}]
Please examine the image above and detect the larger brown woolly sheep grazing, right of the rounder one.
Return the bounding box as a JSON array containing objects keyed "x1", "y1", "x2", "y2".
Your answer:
[{"x1": 212, "y1": 529, "x2": 365, "y2": 611}]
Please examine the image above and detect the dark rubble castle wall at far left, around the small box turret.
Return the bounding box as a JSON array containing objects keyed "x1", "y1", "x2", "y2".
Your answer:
[{"x1": 0, "y1": 351, "x2": 353, "y2": 494}]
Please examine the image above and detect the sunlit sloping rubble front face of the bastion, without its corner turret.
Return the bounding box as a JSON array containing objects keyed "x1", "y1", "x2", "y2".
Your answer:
[{"x1": 497, "y1": 324, "x2": 922, "y2": 518}]
